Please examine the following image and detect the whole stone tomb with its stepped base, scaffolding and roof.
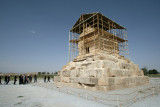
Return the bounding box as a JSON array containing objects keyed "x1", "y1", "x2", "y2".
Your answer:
[{"x1": 54, "y1": 13, "x2": 149, "y2": 91}]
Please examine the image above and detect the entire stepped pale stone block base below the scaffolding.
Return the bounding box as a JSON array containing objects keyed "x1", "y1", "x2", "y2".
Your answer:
[{"x1": 54, "y1": 54, "x2": 149, "y2": 91}]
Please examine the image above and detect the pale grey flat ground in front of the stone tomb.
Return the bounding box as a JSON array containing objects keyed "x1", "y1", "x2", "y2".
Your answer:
[{"x1": 0, "y1": 78, "x2": 160, "y2": 107}]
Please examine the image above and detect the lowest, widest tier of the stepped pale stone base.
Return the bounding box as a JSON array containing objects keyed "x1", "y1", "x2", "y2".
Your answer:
[{"x1": 54, "y1": 76, "x2": 149, "y2": 91}]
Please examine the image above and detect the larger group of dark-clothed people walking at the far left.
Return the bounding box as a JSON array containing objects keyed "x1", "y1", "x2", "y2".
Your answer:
[{"x1": 0, "y1": 75, "x2": 37, "y2": 85}]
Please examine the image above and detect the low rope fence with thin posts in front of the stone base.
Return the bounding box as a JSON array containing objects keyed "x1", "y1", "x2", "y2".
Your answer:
[{"x1": 34, "y1": 78, "x2": 160, "y2": 107}]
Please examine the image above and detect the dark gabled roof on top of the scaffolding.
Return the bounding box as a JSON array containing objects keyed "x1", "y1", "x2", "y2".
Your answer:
[{"x1": 70, "y1": 12, "x2": 126, "y2": 33}]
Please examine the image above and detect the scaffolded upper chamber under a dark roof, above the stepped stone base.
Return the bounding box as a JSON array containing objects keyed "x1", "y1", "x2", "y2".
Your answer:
[{"x1": 69, "y1": 13, "x2": 129, "y2": 61}]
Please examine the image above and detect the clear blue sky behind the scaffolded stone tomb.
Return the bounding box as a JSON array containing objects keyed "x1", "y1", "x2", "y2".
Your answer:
[{"x1": 0, "y1": 0, "x2": 160, "y2": 73}]
